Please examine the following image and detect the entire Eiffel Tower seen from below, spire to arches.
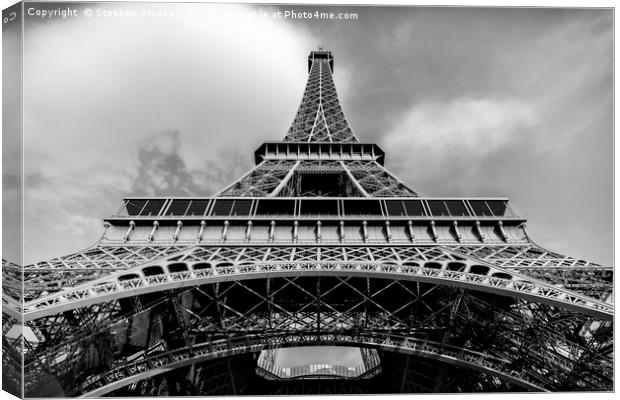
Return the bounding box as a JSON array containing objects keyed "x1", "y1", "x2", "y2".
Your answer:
[{"x1": 2, "y1": 49, "x2": 614, "y2": 397}]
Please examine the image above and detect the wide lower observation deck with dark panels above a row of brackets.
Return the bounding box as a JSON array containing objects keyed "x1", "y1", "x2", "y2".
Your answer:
[{"x1": 102, "y1": 197, "x2": 527, "y2": 245}]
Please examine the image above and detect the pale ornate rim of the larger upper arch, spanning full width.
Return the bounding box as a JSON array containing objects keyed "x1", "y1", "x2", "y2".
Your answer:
[{"x1": 23, "y1": 247, "x2": 614, "y2": 320}]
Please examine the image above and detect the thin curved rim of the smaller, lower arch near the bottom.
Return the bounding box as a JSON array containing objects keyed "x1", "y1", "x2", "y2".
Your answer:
[{"x1": 76, "y1": 334, "x2": 545, "y2": 397}]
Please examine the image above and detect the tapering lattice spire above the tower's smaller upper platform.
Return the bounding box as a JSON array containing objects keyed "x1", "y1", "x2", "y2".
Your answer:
[{"x1": 284, "y1": 47, "x2": 358, "y2": 142}]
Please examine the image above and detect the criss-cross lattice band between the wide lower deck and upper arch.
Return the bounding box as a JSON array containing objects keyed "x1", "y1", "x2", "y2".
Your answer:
[{"x1": 17, "y1": 244, "x2": 613, "y2": 302}]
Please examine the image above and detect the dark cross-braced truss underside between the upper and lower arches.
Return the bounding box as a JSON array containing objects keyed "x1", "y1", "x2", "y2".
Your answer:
[{"x1": 25, "y1": 275, "x2": 613, "y2": 395}]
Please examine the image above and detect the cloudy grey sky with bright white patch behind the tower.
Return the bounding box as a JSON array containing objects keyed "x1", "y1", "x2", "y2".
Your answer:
[{"x1": 4, "y1": 3, "x2": 613, "y2": 265}]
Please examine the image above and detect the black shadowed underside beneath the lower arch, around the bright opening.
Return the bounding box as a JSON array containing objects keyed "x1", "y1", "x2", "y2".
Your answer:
[{"x1": 107, "y1": 349, "x2": 524, "y2": 397}]
